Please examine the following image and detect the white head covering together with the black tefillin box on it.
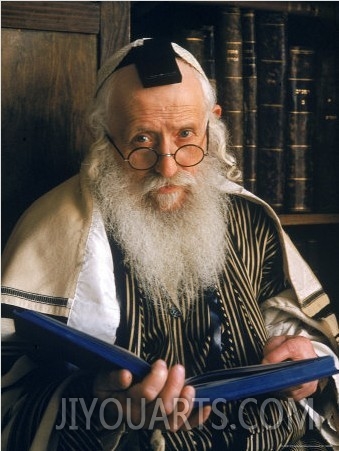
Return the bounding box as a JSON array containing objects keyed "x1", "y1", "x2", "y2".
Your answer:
[{"x1": 97, "y1": 39, "x2": 206, "y2": 92}]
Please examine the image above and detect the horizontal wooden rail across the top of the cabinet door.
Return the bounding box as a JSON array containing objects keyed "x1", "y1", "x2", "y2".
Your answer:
[{"x1": 1, "y1": 2, "x2": 99, "y2": 34}]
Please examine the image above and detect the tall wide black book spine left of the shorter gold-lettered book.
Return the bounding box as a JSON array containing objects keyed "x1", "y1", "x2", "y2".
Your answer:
[{"x1": 257, "y1": 12, "x2": 287, "y2": 212}]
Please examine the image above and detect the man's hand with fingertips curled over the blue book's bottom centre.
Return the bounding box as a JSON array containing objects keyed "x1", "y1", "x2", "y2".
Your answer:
[{"x1": 93, "y1": 360, "x2": 211, "y2": 432}]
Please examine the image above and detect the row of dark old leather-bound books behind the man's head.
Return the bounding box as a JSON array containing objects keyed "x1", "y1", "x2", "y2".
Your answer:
[{"x1": 131, "y1": 1, "x2": 339, "y2": 213}]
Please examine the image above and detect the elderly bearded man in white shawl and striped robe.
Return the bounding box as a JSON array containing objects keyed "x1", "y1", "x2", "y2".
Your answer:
[{"x1": 3, "y1": 39, "x2": 339, "y2": 451}]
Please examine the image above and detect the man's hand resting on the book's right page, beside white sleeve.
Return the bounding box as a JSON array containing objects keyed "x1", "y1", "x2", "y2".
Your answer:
[{"x1": 262, "y1": 335, "x2": 318, "y2": 401}]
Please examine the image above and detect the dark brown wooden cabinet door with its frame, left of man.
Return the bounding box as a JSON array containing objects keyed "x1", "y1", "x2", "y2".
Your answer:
[{"x1": 1, "y1": 1, "x2": 130, "y2": 249}]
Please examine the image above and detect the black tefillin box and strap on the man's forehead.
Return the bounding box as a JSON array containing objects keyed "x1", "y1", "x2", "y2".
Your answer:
[{"x1": 115, "y1": 39, "x2": 182, "y2": 88}]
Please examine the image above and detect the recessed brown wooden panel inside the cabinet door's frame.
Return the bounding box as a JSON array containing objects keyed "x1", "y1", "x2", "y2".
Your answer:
[{"x1": 1, "y1": 29, "x2": 97, "y2": 243}]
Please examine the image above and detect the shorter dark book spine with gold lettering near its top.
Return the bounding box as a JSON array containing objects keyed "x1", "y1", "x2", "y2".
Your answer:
[{"x1": 286, "y1": 46, "x2": 315, "y2": 213}]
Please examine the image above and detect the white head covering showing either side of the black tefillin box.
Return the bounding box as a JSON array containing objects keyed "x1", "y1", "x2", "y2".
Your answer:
[{"x1": 96, "y1": 38, "x2": 207, "y2": 92}]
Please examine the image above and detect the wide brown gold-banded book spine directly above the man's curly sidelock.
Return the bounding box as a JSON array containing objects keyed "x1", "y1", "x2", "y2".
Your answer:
[{"x1": 215, "y1": 6, "x2": 244, "y2": 178}]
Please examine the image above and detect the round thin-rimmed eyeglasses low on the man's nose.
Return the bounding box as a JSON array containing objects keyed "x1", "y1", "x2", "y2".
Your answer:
[{"x1": 106, "y1": 132, "x2": 208, "y2": 171}]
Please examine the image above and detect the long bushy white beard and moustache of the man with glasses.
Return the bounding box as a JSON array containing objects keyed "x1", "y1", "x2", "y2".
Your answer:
[{"x1": 92, "y1": 152, "x2": 228, "y2": 312}]
